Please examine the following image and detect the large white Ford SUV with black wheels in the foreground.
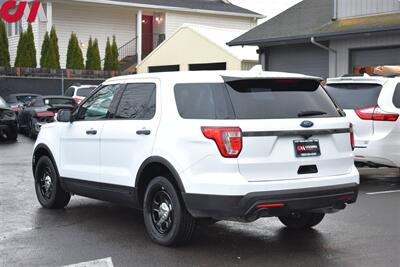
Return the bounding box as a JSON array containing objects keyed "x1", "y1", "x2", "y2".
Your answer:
[{"x1": 33, "y1": 72, "x2": 359, "y2": 245}]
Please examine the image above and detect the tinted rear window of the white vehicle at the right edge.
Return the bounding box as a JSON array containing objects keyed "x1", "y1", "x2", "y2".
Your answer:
[{"x1": 326, "y1": 83, "x2": 382, "y2": 110}]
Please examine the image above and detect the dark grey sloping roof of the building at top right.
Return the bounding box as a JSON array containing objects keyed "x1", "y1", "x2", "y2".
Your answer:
[{"x1": 228, "y1": 0, "x2": 400, "y2": 46}]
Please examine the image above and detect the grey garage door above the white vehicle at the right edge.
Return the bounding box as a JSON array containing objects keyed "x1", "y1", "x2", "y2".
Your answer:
[{"x1": 350, "y1": 47, "x2": 400, "y2": 71}]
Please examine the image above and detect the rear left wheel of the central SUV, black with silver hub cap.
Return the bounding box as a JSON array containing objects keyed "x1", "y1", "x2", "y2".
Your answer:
[{"x1": 143, "y1": 176, "x2": 196, "y2": 246}]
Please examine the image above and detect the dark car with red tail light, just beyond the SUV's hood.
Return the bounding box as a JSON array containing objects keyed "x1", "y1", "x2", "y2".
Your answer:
[{"x1": 19, "y1": 96, "x2": 77, "y2": 138}]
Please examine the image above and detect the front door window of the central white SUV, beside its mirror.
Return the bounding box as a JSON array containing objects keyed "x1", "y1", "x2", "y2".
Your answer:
[{"x1": 78, "y1": 84, "x2": 120, "y2": 120}]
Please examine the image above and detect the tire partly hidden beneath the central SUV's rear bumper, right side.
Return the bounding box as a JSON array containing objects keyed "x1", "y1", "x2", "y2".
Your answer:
[{"x1": 279, "y1": 212, "x2": 325, "y2": 230}]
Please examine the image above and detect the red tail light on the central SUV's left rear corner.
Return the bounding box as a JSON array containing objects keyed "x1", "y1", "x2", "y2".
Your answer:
[{"x1": 201, "y1": 127, "x2": 242, "y2": 158}]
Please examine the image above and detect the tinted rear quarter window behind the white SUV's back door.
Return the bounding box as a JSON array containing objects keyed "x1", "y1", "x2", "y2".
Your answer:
[{"x1": 175, "y1": 83, "x2": 235, "y2": 120}]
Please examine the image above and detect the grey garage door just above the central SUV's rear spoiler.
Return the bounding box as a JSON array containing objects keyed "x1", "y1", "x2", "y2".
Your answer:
[{"x1": 266, "y1": 44, "x2": 329, "y2": 78}]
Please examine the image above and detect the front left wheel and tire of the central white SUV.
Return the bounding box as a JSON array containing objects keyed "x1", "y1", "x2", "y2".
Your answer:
[{"x1": 35, "y1": 156, "x2": 71, "y2": 209}]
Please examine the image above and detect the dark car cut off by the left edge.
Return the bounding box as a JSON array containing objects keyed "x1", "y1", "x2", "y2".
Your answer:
[{"x1": 0, "y1": 97, "x2": 18, "y2": 141}]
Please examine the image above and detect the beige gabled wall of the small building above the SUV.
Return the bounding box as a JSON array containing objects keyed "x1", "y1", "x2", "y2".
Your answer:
[{"x1": 137, "y1": 28, "x2": 242, "y2": 73}]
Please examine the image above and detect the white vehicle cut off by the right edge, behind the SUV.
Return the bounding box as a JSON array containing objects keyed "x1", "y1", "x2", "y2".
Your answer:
[{"x1": 326, "y1": 75, "x2": 400, "y2": 168}]
